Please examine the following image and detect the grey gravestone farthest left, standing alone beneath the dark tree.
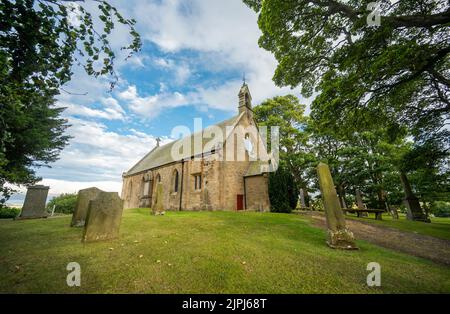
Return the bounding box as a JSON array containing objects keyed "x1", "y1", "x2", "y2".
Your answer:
[{"x1": 17, "y1": 185, "x2": 50, "y2": 219}]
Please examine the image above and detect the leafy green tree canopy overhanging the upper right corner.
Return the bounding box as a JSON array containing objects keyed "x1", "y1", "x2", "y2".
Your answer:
[{"x1": 243, "y1": 0, "x2": 450, "y2": 151}]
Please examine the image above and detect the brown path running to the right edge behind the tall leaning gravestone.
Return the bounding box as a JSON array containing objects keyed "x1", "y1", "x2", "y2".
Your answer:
[{"x1": 299, "y1": 212, "x2": 450, "y2": 266}]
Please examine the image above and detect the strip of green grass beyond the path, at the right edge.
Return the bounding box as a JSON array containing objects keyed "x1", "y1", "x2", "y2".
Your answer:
[{"x1": 346, "y1": 213, "x2": 450, "y2": 240}]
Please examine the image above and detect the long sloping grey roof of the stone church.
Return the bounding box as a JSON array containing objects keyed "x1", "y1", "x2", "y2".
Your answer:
[{"x1": 124, "y1": 113, "x2": 243, "y2": 176}]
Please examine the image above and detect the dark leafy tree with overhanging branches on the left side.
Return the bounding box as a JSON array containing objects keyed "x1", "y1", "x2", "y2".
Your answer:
[{"x1": 0, "y1": 0, "x2": 141, "y2": 206}]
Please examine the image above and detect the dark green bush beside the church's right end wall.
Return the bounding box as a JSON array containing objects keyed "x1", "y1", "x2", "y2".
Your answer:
[{"x1": 269, "y1": 166, "x2": 299, "y2": 213}]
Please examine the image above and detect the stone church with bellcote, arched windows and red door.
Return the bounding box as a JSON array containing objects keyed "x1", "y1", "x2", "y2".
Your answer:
[{"x1": 122, "y1": 82, "x2": 273, "y2": 210}]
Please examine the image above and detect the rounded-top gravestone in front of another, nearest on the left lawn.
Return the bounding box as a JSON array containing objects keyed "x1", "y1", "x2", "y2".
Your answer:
[{"x1": 82, "y1": 191, "x2": 123, "y2": 242}]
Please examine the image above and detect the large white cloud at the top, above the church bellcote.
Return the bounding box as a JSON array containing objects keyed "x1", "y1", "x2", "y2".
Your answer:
[{"x1": 126, "y1": 0, "x2": 306, "y2": 111}]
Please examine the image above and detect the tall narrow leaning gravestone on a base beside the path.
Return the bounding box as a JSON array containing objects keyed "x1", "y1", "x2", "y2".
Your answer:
[{"x1": 317, "y1": 162, "x2": 358, "y2": 250}]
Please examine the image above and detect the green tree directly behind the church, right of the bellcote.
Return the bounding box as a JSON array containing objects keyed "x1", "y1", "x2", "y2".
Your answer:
[{"x1": 253, "y1": 95, "x2": 313, "y2": 205}]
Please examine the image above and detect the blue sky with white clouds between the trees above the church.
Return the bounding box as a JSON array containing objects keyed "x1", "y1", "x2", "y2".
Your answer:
[{"x1": 10, "y1": 0, "x2": 310, "y2": 203}]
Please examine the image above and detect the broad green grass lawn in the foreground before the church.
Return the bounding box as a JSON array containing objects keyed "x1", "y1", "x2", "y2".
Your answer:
[{"x1": 0, "y1": 209, "x2": 450, "y2": 293}]
